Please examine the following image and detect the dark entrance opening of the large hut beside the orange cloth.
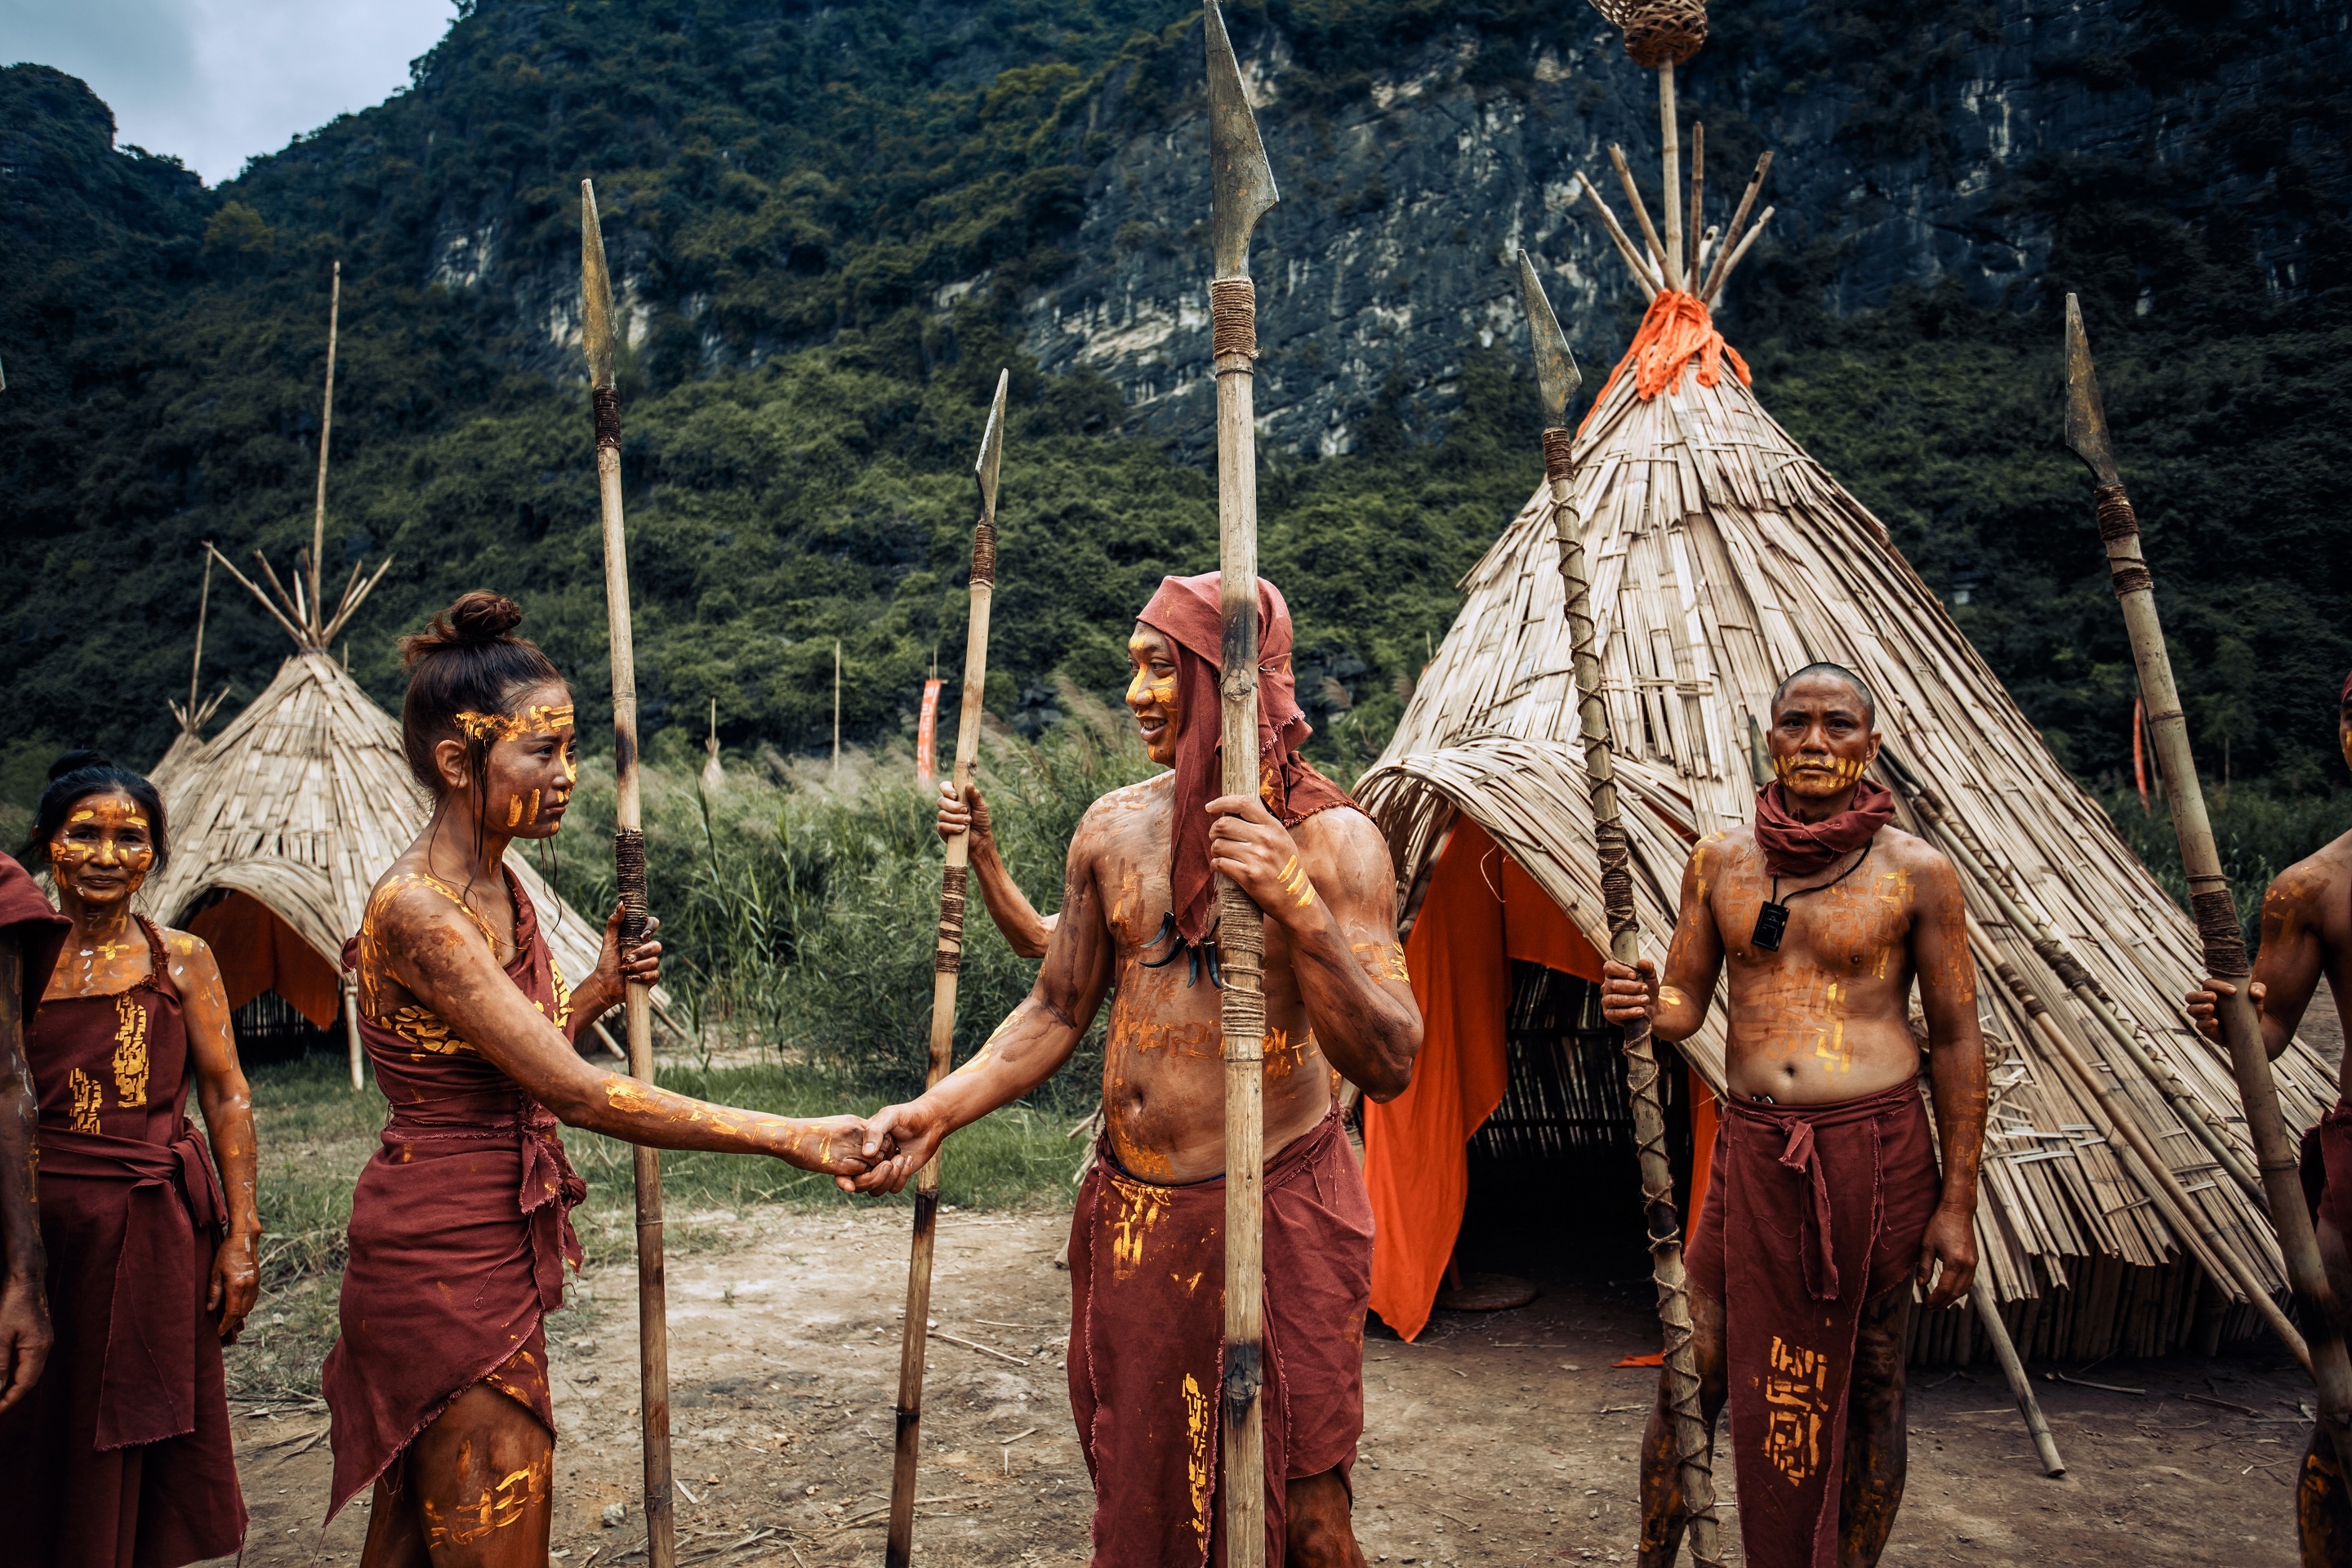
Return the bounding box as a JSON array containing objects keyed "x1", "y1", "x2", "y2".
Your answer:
[{"x1": 1440, "y1": 959, "x2": 1691, "y2": 1303}]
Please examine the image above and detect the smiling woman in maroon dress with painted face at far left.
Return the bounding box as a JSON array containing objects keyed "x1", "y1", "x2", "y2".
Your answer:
[{"x1": 0, "y1": 752, "x2": 261, "y2": 1568}]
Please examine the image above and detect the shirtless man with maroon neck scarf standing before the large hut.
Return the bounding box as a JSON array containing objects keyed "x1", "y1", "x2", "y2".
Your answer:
[{"x1": 1601, "y1": 666, "x2": 1985, "y2": 1568}]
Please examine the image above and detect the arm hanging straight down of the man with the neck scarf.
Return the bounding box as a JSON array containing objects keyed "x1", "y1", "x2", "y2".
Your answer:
[{"x1": 1912, "y1": 856, "x2": 1985, "y2": 1312}]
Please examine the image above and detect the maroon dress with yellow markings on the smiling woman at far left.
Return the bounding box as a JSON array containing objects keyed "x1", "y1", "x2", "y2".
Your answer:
[{"x1": 0, "y1": 920, "x2": 245, "y2": 1568}]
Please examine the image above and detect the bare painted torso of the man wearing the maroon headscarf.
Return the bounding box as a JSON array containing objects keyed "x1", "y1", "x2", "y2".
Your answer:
[{"x1": 1080, "y1": 773, "x2": 1354, "y2": 1185}]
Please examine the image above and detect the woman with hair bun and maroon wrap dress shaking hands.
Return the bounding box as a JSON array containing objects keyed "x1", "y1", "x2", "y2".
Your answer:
[{"x1": 324, "y1": 592, "x2": 868, "y2": 1568}]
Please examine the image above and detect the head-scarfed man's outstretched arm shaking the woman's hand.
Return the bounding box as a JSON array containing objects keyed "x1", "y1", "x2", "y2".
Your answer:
[{"x1": 837, "y1": 811, "x2": 1112, "y2": 1192}]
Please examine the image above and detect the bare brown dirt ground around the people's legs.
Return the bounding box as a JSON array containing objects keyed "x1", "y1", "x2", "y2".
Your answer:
[{"x1": 202, "y1": 1210, "x2": 2310, "y2": 1568}]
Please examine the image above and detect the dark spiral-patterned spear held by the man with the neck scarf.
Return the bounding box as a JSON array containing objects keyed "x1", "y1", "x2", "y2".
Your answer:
[{"x1": 1519, "y1": 252, "x2": 1724, "y2": 1568}]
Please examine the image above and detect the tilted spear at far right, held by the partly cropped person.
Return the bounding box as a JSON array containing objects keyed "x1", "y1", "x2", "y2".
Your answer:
[{"x1": 2065, "y1": 294, "x2": 2352, "y2": 1469}]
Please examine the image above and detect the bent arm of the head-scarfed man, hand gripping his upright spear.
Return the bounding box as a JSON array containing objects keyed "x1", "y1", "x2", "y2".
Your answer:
[{"x1": 1209, "y1": 795, "x2": 1421, "y2": 1100}]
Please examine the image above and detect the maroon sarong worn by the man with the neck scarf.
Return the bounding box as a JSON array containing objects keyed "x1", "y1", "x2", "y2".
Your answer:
[{"x1": 1686, "y1": 1079, "x2": 1943, "y2": 1568}]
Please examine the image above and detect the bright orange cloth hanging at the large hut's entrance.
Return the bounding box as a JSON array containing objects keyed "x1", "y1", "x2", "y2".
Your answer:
[{"x1": 1364, "y1": 818, "x2": 1601, "y2": 1340}]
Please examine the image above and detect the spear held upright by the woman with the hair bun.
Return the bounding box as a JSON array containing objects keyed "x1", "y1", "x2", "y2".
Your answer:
[{"x1": 581, "y1": 179, "x2": 677, "y2": 1568}]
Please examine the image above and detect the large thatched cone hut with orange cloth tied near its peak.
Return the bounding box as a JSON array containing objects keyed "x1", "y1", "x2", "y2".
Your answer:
[{"x1": 1357, "y1": 104, "x2": 2336, "y2": 1359}]
